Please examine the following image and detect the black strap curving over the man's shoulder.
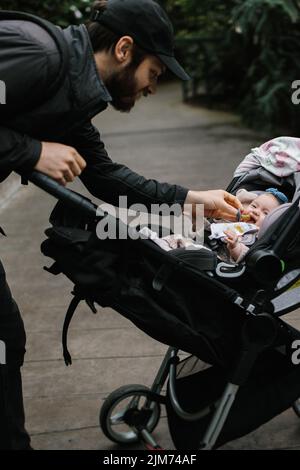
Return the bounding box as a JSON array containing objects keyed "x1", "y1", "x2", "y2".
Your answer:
[{"x1": 0, "y1": 10, "x2": 69, "y2": 112}]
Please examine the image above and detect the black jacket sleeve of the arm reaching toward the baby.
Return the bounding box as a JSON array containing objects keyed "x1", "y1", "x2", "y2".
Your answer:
[{"x1": 69, "y1": 122, "x2": 188, "y2": 208}]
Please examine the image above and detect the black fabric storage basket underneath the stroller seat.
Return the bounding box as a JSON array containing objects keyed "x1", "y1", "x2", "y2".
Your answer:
[{"x1": 167, "y1": 350, "x2": 300, "y2": 450}]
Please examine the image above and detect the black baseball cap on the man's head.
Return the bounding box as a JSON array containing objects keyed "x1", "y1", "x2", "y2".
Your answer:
[{"x1": 90, "y1": 0, "x2": 190, "y2": 80}]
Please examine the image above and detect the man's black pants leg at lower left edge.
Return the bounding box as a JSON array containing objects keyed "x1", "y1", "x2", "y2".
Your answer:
[{"x1": 0, "y1": 262, "x2": 30, "y2": 450}]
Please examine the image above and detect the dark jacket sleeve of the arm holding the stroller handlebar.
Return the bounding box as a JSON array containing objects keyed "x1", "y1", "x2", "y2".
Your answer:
[{"x1": 0, "y1": 21, "x2": 58, "y2": 181}]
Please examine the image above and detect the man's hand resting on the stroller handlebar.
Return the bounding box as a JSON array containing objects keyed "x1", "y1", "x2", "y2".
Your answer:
[{"x1": 34, "y1": 142, "x2": 86, "y2": 186}]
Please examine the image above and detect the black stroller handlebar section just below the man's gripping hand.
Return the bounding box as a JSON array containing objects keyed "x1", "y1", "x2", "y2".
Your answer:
[{"x1": 22, "y1": 171, "x2": 101, "y2": 218}]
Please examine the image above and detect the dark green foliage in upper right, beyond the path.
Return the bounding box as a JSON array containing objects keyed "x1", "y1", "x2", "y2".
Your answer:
[{"x1": 162, "y1": 0, "x2": 300, "y2": 133}]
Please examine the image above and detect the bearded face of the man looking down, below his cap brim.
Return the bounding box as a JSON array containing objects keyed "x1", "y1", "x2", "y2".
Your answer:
[{"x1": 106, "y1": 55, "x2": 165, "y2": 112}]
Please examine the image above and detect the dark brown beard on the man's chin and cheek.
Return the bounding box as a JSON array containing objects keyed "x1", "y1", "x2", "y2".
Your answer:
[{"x1": 106, "y1": 64, "x2": 137, "y2": 113}]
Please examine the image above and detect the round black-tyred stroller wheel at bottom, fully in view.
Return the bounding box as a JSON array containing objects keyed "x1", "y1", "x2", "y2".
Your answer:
[{"x1": 99, "y1": 385, "x2": 161, "y2": 444}]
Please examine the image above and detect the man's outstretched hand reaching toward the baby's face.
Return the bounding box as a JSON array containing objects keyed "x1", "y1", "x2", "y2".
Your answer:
[{"x1": 185, "y1": 189, "x2": 242, "y2": 221}]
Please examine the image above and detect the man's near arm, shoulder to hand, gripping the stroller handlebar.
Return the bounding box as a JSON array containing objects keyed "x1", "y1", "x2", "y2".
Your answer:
[{"x1": 0, "y1": 20, "x2": 85, "y2": 184}]
